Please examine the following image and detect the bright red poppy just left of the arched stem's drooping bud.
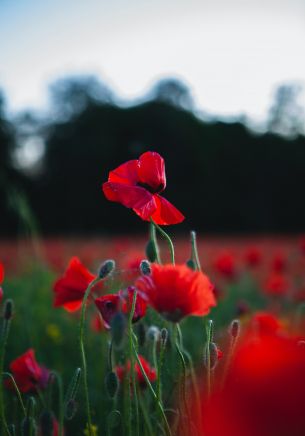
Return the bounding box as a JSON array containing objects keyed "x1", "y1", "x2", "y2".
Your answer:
[{"x1": 53, "y1": 257, "x2": 96, "y2": 312}]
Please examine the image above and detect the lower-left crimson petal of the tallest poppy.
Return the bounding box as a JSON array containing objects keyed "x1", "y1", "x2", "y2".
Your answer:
[{"x1": 103, "y1": 182, "x2": 156, "y2": 213}]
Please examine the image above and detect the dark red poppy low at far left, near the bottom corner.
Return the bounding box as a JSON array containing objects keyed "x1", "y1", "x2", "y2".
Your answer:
[{"x1": 6, "y1": 348, "x2": 49, "y2": 392}]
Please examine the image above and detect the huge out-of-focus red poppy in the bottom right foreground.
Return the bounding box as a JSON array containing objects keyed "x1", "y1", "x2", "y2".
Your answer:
[{"x1": 196, "y1": 335, "x2": 305, "y2": 436}]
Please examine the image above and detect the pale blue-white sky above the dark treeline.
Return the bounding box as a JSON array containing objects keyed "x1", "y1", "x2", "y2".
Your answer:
[{"x1": 0, "y1": 0, "x2": 305, "y2": 120}]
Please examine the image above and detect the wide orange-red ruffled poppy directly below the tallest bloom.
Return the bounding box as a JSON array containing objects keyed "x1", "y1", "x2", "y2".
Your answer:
[{"x1": 135, "y1": 264, "x2": 216, "y2": 322}]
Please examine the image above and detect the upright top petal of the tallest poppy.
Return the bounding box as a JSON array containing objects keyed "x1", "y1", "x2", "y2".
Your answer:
[{"x1": 138, "y1": 151, "x2": 166, "y2": 192}]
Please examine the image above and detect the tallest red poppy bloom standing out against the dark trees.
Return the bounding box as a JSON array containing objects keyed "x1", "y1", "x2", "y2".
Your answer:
[{"x1": 102, "y1": 151, "x2": 184, "y2": 225}]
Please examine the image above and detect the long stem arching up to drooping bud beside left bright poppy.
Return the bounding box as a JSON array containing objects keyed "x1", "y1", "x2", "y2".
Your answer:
[{"x1": 79, "y1": 277, "x2": 101, "y2": 436}]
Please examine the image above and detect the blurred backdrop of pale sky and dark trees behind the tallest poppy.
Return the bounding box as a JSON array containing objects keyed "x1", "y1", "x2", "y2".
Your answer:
[{"x1": 0, "y1": 0, "x2": 305, "y2": 239}]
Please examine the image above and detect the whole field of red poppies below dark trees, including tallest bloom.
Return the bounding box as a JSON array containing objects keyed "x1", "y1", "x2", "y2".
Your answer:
[{"x1": 0, "y1": 152, "x2": 305, "y2": 436}]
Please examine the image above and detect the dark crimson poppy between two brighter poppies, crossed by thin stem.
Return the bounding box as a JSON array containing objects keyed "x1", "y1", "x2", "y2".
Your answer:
[{"x1": 95, "y1": 286, "x2": 146, "y2": 328}]
